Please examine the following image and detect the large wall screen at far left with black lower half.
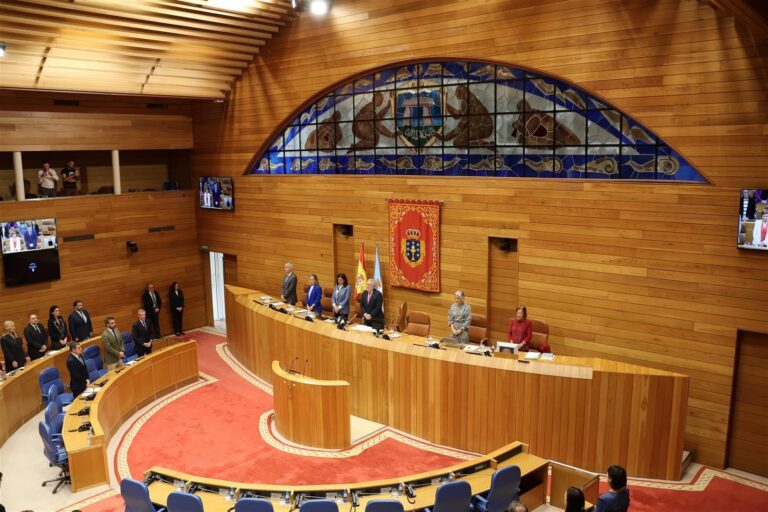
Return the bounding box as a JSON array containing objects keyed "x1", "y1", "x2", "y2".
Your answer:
[{"x1": 0, "y1": 219, "x2": 61, "y2": 286}]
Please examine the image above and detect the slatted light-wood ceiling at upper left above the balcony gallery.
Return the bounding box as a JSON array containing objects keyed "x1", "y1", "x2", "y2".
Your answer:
[{"x1": 0, "y1": 0, "x2": 298, "y2": 98}]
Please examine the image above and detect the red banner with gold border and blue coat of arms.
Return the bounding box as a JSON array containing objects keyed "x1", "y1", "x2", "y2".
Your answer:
[{"x1": 389, "y1": 199, "x2": 440, "y2": 292}]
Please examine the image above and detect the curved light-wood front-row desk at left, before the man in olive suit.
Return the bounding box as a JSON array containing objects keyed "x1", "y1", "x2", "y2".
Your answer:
[{"x1": 62, "y1": 341, "x2": 198, "y2": 492}]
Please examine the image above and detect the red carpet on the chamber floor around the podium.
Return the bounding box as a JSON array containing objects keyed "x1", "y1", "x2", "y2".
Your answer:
[{"x1": 67, "y1": 332, "x2": 768, "y2": 512}]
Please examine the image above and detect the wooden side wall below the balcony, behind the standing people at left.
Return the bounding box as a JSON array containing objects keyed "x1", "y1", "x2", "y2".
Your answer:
[{"x1": 0, "y1": 192, "x2": 206, "y2": 344}]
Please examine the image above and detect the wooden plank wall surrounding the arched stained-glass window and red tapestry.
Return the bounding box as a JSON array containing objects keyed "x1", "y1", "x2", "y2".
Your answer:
[{"x1": 192, "y1": 0, "x2": 768, "y2": 472}]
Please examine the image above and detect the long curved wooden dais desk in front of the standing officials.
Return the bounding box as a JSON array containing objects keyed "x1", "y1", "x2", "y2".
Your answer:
[{"x1": 226, "y1": 286, "x2": 689, "y2": 479}]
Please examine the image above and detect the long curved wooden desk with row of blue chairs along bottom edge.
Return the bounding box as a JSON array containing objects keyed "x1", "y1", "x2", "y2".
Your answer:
[{"x1": 145, "y1": 442, "x2": 548, "y2": 512}]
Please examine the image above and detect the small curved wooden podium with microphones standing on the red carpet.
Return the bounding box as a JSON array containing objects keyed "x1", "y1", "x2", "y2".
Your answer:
[{"x1": 272, "y1": 361, "x2": 352, "y2": 449}]
